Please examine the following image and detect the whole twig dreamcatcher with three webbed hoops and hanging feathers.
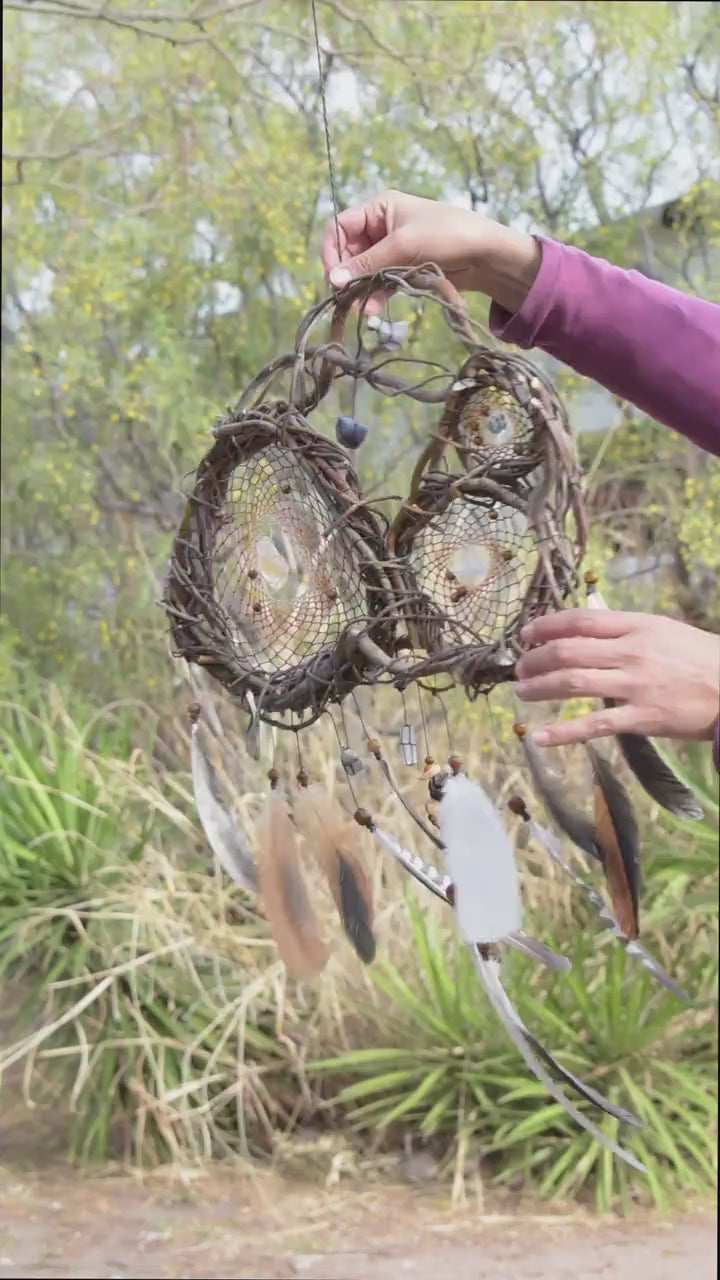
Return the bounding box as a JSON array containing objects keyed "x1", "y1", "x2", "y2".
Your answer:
[{"x1": 165, "y1": 2, "x2": 701, "y2": 1170}]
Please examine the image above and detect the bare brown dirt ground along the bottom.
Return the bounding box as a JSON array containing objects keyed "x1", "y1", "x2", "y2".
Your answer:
[{"x1": 0, "y1": 1166, "x2": 717, "y2": 1280}]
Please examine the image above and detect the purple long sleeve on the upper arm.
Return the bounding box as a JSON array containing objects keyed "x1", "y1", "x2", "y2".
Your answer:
[{"x1": 489, "y1": 237, "x2": 720, "y2": 454}]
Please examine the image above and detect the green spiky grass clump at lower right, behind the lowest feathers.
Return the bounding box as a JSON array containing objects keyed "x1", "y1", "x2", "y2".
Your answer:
[{"x1": 310, "y1": 908, "x2": 716, "y2": 1212}]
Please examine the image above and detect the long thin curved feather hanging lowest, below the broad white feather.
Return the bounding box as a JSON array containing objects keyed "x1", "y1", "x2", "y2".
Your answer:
[{"x1": 471, "y1": 947, "x2": 647, "y2": 1174}]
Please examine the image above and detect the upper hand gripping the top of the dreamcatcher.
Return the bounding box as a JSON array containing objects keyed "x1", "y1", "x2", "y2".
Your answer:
[{"x1": 322, "y1": 191, "x2": 542, "y2": 312}]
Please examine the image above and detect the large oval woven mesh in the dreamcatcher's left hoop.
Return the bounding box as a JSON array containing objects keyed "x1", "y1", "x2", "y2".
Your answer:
[{"x1": 213, "y1": 445, "x2": 368, "y2": 673}]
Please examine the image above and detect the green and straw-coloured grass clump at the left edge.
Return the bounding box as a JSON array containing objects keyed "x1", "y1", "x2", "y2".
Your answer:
[{"x1": 0, "y1": 692, "x2": 292, "y2": 1164}]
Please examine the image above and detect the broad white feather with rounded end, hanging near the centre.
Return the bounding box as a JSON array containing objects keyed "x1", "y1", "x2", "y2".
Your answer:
[{"x1": 438, "y1": 773, "x2": 523, "y2": 943}]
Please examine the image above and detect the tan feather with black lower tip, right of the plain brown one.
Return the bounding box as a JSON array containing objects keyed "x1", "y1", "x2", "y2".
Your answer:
[{"x1": 295, "y1": 787, "x2": 375, "y2": 964}]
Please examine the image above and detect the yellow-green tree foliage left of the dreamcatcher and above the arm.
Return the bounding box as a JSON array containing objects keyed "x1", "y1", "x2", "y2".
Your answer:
[{"x1": 1, "y1": 0, "x2": 720, "y2": 691}]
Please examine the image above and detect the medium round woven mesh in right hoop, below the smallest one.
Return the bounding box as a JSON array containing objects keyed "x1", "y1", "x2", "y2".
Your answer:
[{"x1": 410, "y1": 498, "x2": 538, "y2": 644}]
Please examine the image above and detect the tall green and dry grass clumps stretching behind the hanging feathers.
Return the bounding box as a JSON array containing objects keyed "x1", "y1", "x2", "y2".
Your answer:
[{"x1": 0, "y1": 689, "x2": 717, "y2": 1210}]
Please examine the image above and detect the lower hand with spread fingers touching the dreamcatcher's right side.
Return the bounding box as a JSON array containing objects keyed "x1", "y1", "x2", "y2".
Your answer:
[{"x1": 515, "y1": 609, "x2": 720, "y2": 746}]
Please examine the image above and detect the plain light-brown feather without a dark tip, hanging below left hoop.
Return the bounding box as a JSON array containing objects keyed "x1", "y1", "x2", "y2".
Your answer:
[{"x1": 259, "y1": 792, "x2": 328, "y2": 978}]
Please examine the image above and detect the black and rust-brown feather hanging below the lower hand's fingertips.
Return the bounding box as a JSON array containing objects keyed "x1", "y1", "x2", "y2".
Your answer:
[{"x1": 585, "y1": 742, "x2": 639, "y2": 941}]
